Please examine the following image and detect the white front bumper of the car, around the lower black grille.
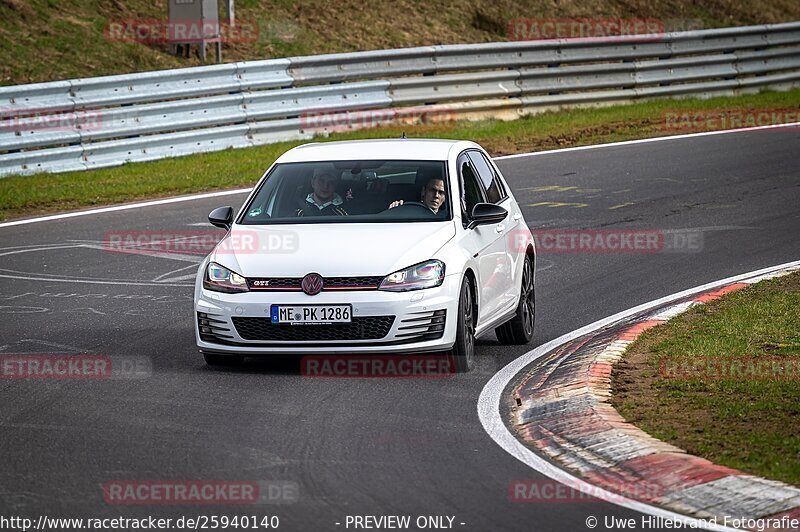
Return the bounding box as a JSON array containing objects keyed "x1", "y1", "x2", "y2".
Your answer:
[{"x1": 194, "y1": 275, "x2": 461, "y2": 356}]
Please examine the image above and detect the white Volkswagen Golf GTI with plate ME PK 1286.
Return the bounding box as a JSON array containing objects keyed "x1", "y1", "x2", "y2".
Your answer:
[{"x1": 194, "y1": 139, "x2": 536, "y2": 372}]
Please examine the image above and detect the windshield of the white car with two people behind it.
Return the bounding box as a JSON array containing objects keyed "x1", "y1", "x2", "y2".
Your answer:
[{"x1": 239, "y1": 160, "x2": 451, "y2": 225}]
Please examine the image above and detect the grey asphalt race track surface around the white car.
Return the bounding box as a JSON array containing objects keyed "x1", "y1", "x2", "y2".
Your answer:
[{"x1": 0, "y1": 128, "x2": 800, "y2": 531}]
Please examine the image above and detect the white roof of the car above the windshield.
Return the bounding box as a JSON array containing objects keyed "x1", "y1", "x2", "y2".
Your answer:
[{"x1": 276, "y1": 139, "x2": 477, "y2": 163}]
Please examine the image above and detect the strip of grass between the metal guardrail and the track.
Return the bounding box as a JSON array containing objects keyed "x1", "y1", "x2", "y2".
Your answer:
[{"x1": 0, "y1": 90, "x2": 800, "y2": 219}]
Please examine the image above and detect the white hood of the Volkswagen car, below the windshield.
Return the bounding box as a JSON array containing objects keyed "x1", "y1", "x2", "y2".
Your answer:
[{"x1": 211, "y1": 221, "x2": 456, "y2": 277}]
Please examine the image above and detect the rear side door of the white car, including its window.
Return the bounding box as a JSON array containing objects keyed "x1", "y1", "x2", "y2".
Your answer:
[{"x1": 468, "y1": 150, "x2": 525, "y2": 313}]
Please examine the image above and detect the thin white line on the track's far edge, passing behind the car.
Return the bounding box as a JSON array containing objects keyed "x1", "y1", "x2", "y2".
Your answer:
[{"x1": 0, "y1": 122, "x2": 800, "y2": 228}]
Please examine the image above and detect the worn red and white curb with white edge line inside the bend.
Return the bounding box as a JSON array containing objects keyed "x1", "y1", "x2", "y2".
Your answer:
[{"x1": 478, "y1": 261, "x2": 800, "y2": 530}]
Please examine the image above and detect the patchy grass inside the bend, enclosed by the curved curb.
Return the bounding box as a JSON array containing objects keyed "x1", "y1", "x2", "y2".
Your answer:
[{"x1": 612, "y1": 273, "x2": 800, "y2": 485}]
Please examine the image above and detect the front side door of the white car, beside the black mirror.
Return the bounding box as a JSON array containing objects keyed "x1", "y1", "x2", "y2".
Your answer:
[{"x1": 457, "y1": 152, "x2": 507, "y2": 325}]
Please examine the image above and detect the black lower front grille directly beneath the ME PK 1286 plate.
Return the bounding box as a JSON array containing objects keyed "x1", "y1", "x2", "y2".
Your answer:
[{"x1": 232, "y1": 316, "x2": 395, "y2": 342}]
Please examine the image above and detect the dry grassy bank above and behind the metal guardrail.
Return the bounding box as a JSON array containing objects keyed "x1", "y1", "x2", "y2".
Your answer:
[{"x1": 0, "y1": 0, "x2": 800, "y2": 85}]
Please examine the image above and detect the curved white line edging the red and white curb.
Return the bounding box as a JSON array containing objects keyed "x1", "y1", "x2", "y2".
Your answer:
[{"x1": 478, "y1": 260, "x2": 800, "y2": 530}]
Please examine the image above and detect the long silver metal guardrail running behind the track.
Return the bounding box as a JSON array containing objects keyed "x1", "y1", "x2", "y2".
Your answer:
[{"x1": 0, "y1": 22, "x2": 800, "y2": 176}]
